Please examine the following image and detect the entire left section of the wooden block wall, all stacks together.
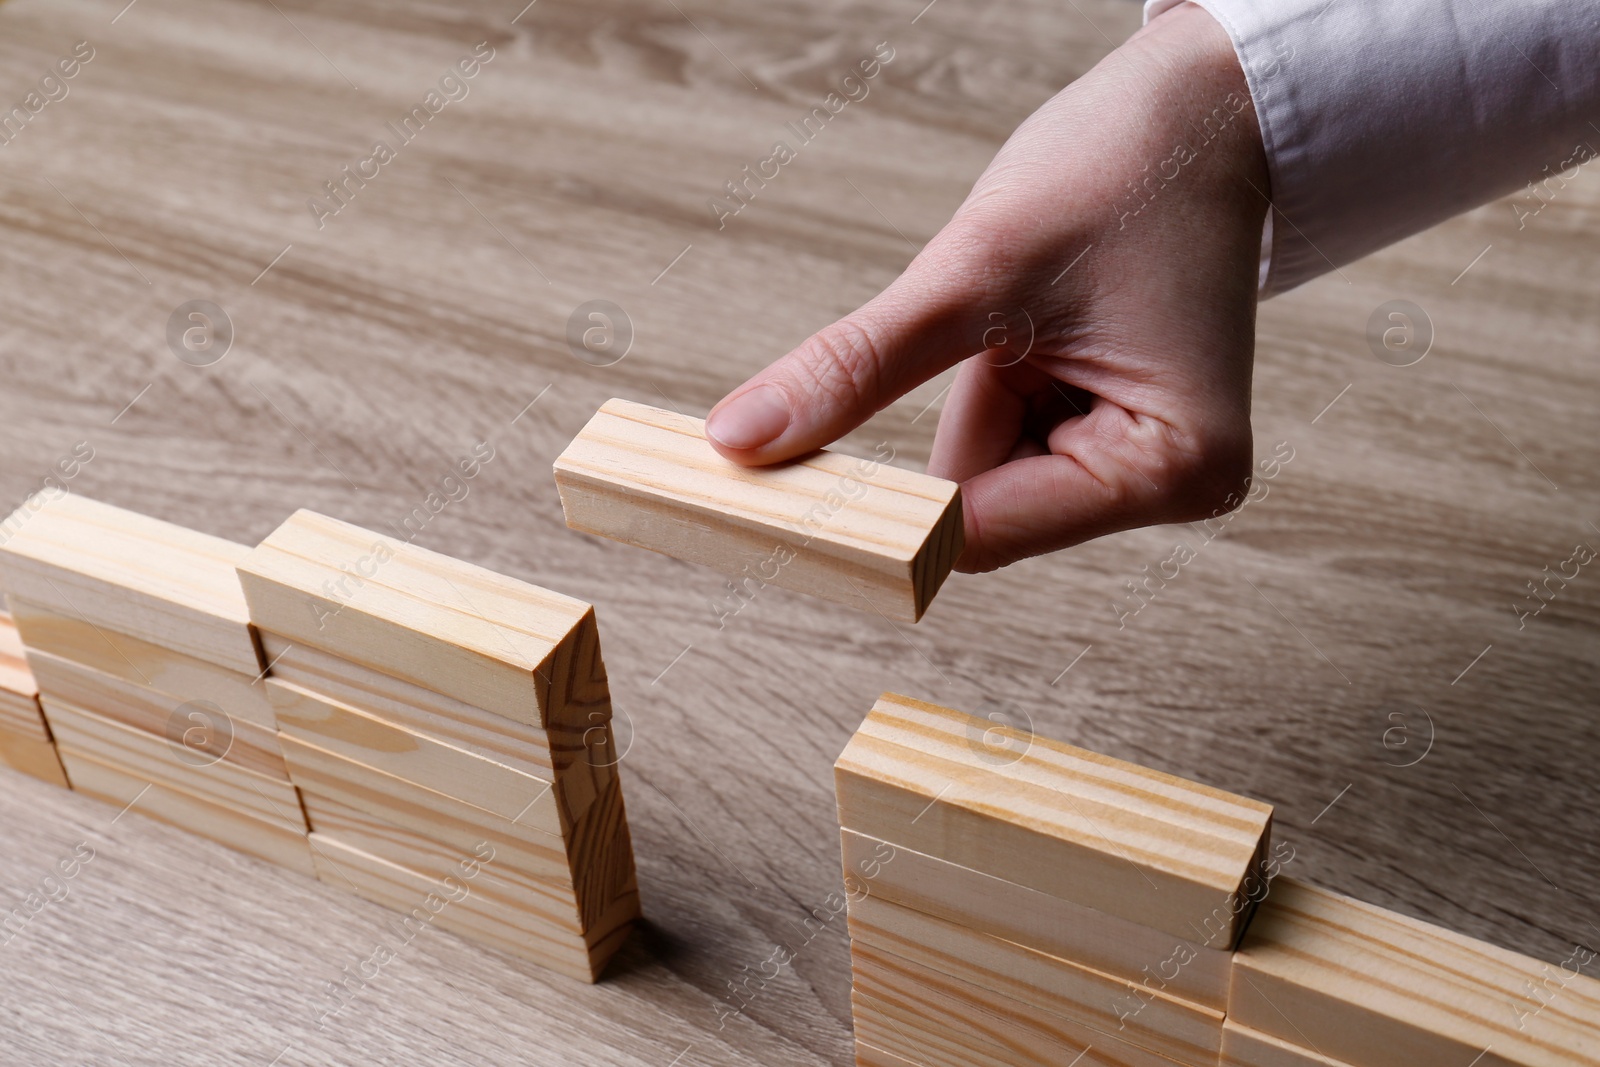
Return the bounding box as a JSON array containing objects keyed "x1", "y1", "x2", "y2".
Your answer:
[{"x1": 0, "y1": 494, "x2": 638, "y2": 982}]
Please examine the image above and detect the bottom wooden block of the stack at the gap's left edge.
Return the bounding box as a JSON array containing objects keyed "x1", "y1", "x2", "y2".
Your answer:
[{"x1": 310, "y1": 833, "x2": 637, "y2": 982}]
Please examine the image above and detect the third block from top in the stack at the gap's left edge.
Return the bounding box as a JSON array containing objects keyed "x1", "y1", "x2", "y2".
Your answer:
[{"x1": 267, "y1": 678, "x2": 594, "y2": 827}]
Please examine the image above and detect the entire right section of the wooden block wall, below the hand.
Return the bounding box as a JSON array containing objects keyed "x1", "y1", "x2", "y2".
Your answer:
[{"x1": 835, "y1": 696, "x2": 1600, "y2": 1067}]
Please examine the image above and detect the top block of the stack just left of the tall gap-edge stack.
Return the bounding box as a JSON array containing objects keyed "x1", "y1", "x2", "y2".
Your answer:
[{"x1": 0, "y1": 493, "x2": 261, "y2": 677}]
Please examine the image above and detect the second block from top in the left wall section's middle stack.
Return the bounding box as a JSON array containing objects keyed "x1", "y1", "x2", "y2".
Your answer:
[{"x1": 11, "y1": 598, "x2": 277, "y2": 729}]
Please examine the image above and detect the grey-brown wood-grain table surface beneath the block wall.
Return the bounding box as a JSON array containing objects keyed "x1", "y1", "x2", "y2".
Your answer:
[{"x1": 0, "y1": 0, "x2": 1600, "y2": 1067}]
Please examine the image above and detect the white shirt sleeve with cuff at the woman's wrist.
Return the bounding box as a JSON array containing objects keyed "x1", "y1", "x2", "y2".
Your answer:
[{"x1": 1144, "y1": 0, "x2": 1600, "y2": 294}]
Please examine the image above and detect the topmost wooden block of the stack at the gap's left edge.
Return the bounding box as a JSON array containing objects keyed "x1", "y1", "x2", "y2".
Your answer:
[{"x1": 238, "y1": 510, "x2": 611, "y2": 728}]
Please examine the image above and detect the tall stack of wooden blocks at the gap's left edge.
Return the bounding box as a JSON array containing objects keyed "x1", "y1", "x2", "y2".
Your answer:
[{"x1": 238, "y1": 512, "x2": 638, "y2": 981}]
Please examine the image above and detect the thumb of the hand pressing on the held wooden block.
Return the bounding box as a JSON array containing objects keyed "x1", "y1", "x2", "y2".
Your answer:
[{"x1": 706, "y1": 259, "x2": 984, "y2": 466}]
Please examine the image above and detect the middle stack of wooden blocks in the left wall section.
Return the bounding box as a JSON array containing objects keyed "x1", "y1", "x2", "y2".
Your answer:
[{"x1": 0, "y1": 494, "x2": 312, "y2": 873}]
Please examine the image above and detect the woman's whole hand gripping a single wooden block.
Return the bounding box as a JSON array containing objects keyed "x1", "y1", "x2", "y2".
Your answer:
[{"x1": 707, "y1": 5, "x2": 1269, "y2": 571}]
